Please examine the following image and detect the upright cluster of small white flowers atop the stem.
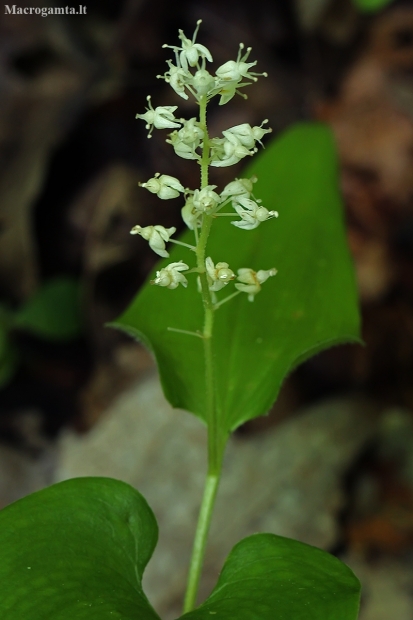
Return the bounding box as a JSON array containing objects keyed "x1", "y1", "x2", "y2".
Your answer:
[{"x1": 131, "y1": 20, "x2": 278, "y2": 309}]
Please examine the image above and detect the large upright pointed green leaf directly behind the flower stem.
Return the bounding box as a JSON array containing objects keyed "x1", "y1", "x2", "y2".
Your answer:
[{"x1": 113, "y1": 124, "x2": 359, "y2": 434}]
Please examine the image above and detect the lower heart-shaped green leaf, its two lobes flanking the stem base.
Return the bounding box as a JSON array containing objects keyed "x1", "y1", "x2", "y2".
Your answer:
[{"x1": 0, "y1": 478, "x2": 360, "y2": 620}]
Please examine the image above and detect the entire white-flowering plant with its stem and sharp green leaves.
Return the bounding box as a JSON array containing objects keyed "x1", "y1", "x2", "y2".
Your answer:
[{"x1": 0, "y1": 22, "x2": 359, "y2": 620}]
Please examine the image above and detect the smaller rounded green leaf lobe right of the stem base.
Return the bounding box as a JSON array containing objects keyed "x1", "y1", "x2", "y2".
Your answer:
[{"x1": 182, "y1": 534, "x2": 360, "y2": 620}]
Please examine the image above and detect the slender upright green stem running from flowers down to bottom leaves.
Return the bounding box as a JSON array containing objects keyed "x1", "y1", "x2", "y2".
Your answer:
[{"x1": 184, "y1": 98, "x2": 225, "y2": 613}]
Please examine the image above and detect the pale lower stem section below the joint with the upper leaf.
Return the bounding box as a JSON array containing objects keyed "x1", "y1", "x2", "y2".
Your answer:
[{"x1": 183, "y1": 472, "x2": 220, "y2": 613}]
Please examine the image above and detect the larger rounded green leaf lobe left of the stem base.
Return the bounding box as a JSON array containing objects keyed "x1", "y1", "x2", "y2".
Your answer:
[{"x1": 0, "y1": 478, "x2": 159, "y2": 620}]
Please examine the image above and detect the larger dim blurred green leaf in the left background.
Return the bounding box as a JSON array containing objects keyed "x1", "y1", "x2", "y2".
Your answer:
[{"x1": 14, "y1": 277, "x2": 82, "y2": 340}]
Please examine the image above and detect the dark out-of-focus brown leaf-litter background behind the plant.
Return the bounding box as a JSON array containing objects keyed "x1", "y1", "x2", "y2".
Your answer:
[{"x1": 0, "y1": 0, "x2": 413, "y2": 620}]
